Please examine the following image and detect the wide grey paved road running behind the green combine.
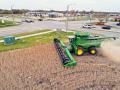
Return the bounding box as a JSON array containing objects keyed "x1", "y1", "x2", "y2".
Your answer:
[{"x1": 0, "y1": 21, "x2": 120, "y2": 37}]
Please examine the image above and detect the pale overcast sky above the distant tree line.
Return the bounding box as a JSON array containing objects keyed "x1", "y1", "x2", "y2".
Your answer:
[{"x1": 0, "y1": 0, "x2": 120, "y2": 12}]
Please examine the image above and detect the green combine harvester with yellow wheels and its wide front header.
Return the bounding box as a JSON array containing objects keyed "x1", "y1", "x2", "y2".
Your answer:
[{"x1": 54, "y1": 32, "x2": 116, "y2": 67}]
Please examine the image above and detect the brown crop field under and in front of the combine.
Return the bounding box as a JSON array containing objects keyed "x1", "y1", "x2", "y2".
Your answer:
[{"x1": 0, "y1": 44, "x2": 120, "y2": 90}]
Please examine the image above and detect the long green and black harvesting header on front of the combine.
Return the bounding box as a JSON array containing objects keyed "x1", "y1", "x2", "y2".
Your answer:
[{"x1": 54, "y1": 38, "x2": 77, "y2": 67}]
